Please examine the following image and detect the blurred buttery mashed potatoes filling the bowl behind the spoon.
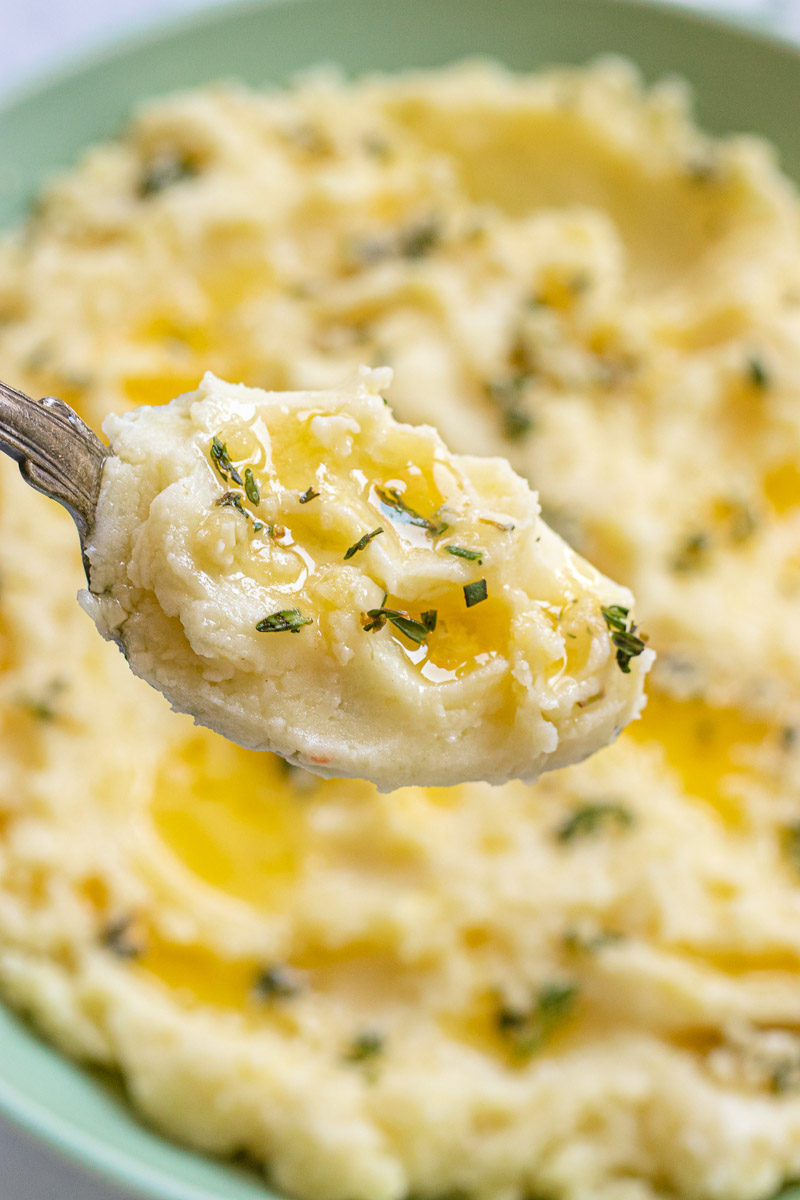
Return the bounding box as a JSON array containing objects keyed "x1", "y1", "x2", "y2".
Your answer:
[{"x1": 0, "y1": 64, "x2": 800, "y2": 1200}]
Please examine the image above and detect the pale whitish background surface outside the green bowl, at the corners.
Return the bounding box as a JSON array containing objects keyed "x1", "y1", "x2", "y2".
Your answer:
[{"x1": 0, "y1": 0, "x2": 800, "y2": 1200}]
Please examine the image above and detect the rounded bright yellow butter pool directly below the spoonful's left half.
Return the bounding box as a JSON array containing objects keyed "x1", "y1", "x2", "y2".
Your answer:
[{"x1": 151, "y1": 730, "x2": 309, "y2": 910}]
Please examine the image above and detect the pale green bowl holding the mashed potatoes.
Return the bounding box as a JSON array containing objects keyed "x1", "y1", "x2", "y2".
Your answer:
[{"x1": 0, "y1": 0, "x2": 800, "y2": 1200}]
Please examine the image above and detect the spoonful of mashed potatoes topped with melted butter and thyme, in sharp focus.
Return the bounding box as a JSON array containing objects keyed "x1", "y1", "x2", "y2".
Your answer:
[{"x1": 83, "y1": 368, "x2": 652, "y2": 790}]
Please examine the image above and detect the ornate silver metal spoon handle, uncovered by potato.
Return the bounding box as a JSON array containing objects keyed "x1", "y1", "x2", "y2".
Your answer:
[{"x1": 0, "y1": 380, "x2": 112, "y2": 580}]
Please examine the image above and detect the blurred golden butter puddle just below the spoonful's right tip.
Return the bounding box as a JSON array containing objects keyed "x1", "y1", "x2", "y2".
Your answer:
[{"x1": 622, "y1": 690, "x2": 771, "y2": 824}]
